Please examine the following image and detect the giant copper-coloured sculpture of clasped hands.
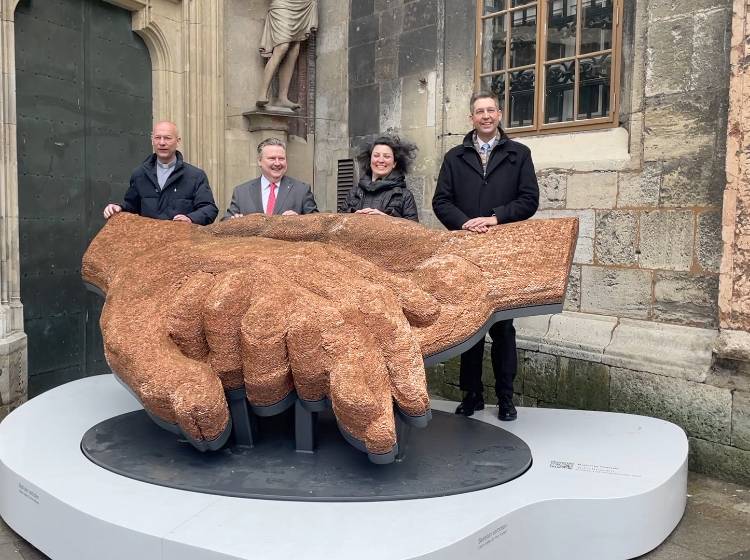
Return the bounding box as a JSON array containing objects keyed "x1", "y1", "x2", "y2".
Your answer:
[{"x1": 83, "y1": 213, "x2": 577, "y2": 454}]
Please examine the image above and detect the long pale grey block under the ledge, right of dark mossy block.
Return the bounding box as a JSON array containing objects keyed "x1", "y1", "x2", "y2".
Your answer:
[{"x1": 610, "y1": 368, "x2": 732, "y2": 444}]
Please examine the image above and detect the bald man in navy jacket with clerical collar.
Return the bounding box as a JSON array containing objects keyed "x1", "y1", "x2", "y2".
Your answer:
[{"x1": 104, "y1": 121, "x2": 219, "y2": 226}]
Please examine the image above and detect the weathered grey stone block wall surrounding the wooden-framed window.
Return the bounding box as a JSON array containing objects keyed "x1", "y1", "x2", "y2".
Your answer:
[{"x1": 317, "y1": 0, "x2": 750, "y2": 483}]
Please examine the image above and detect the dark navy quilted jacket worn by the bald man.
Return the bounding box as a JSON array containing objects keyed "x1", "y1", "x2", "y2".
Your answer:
[{"x1": 121, "y1": 152, "x2": 219, "y2": 226}]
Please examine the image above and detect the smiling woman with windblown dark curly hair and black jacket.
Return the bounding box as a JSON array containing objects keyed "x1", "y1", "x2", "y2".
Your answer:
[{"x1": 339, "y1": 136, "x2": 419, "y2": 222}]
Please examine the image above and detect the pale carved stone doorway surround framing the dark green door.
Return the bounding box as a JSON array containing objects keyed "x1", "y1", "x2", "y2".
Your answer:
[{"x1": 0, "y1": 0, "x2": 315, "y2": 410}]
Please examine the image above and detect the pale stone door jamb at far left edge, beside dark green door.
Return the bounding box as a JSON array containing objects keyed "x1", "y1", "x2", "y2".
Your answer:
[{"x1": 0, "y1": 0, "x2": 28, "y2": 419}]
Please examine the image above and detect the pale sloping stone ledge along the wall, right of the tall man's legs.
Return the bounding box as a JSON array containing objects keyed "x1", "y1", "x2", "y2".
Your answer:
[{"x1": 515, "y1": 311, "x2": 718, "y2": 382}]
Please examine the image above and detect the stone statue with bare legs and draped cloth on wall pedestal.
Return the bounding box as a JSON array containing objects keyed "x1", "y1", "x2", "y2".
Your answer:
[{"x1": 256, "y1": 0, "x2": 318, "y2": 110}]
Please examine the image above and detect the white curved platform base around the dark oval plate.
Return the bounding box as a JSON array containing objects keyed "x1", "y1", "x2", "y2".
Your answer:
[{"x1": 0, "y1": 375, "x2": 688, "y2": 560}]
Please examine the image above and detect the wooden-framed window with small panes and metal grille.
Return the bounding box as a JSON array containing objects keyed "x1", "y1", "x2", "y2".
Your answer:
[{"x1": 475, "y1": 0, "x2": 623, "y2": 134}]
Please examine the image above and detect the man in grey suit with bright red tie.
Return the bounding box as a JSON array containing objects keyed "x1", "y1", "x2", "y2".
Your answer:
[{"x1": 223, "y1": 138, "x2": 318, "y2": 220}]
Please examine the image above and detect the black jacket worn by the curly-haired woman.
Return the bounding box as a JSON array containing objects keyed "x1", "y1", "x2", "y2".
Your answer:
[{"x1": 339, "y1": 171, "x2": 419, "y2": 222}]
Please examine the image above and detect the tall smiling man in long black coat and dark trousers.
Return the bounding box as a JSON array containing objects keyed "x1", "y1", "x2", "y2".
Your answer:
[{"x1": 432, "y1": 92, "x2": 539, "y2": 421}]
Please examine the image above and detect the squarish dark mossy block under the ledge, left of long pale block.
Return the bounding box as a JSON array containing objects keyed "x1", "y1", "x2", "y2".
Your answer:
[{"x1": 557, "y1": 358, "x2": 609, "y2": 410}]
